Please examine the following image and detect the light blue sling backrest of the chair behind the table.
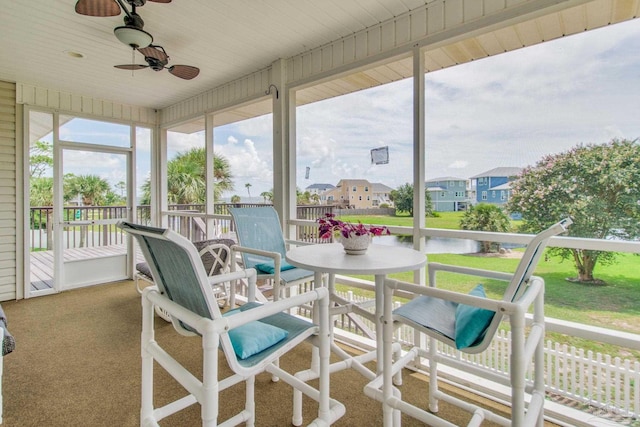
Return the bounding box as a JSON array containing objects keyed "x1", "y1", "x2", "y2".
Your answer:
[{"x1": 229, "y1": 206, "x2": 286, "y2": 268}]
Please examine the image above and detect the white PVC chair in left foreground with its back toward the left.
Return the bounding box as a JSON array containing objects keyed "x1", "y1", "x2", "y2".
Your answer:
[{"x1": 119, "y1": 222, "x2": 345, "y2": 426}]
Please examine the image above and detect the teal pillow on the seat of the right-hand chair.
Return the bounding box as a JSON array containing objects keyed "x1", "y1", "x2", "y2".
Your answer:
[{"x1": 455, "y1": 285, "x2": 496, "y2": 350}]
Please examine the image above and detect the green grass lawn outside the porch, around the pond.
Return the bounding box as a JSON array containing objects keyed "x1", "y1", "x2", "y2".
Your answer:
[{"x1": 330, "y1": 212, "x2": 640, "y2": 360}]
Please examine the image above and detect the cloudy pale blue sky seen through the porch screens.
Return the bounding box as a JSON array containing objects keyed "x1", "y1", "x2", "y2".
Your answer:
[{"x1": 46, "y1": 20, "x2": 640, "y2": 200}]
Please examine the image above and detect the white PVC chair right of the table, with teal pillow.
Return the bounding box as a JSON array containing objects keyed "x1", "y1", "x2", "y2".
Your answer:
[{"x1": 365, "y1": 218, "x2": 572, "y2": 427}]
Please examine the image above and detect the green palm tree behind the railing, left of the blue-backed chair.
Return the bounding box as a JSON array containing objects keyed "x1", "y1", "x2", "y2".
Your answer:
[{"x1": 140, "y1": 148, "x2": 233, "y2": 205}]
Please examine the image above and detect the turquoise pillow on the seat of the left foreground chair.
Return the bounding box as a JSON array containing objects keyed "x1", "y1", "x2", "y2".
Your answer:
[{"x1": 223, "y1": 309, "x2": 289, "y2": 360}]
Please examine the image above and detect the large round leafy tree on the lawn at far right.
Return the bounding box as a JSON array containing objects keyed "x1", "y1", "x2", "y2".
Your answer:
[{"x1": 508, "y1": 139, "x2": 640, "y2": 282}]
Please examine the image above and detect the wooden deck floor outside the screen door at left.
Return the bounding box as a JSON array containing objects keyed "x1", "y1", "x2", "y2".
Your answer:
[{"x1": 31, "y1": 245, "x2": 143, "y2": 291}]
